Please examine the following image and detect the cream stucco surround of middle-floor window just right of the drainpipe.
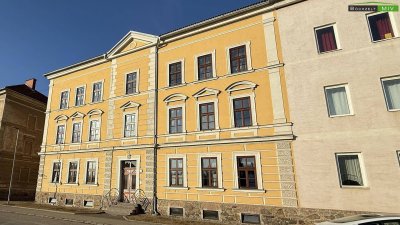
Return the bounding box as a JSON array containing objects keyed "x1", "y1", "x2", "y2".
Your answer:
[{"x1": 164, "y1": 94, "x2": 188, "y2": 135}]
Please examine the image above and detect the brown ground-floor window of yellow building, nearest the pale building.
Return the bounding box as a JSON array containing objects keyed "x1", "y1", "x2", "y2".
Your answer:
[{"x1": 237, "y1": 156, "x2": 257, "y2": 189}]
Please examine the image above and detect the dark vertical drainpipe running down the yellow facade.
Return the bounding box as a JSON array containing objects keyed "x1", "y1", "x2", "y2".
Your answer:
[{"x1": 153, "y1": 38, "x2": 160, "y2": 215}]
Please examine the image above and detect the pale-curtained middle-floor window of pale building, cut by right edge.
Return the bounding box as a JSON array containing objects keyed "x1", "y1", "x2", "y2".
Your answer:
[{"x1": 382, "y1": 77, "x2": 400, "y2": 110}]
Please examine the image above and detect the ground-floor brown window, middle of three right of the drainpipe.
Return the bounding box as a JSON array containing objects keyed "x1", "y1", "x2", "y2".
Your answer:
[{"x1": 201, "y1": 157, "x2": 218, "y2": 188}]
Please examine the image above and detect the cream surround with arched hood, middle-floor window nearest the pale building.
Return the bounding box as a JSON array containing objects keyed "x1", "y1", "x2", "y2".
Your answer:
[{"x1": 226, "y1": 81, "x2": 258, "y2": 129}]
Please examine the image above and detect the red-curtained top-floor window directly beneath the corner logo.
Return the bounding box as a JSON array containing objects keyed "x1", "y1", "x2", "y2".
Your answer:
[{"x1": 367, "y1": 12, "x2": 395, "y2": 41}]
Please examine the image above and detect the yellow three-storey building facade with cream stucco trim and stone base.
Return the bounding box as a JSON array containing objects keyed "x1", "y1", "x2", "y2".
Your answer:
[{"x1": 36, "y1": 2, "x2": 297, "y2": 221}]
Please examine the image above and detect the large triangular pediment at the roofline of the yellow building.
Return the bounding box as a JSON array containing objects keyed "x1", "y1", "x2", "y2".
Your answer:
[{"x1": 107, "y1": 31, "x2": 158, "y2": 57}]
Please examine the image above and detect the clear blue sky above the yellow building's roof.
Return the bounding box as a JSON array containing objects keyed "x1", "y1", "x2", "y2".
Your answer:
[{"x1": 0, "y1": 0, "x2": 258, "y2": 95}]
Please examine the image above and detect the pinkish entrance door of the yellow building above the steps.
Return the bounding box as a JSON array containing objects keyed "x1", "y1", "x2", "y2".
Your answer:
[{"x1": 120, "y1": 160, "x2": 137, "y2": 202}]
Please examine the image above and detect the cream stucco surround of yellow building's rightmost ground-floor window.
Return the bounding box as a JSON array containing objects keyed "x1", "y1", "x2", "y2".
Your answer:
[{"x1": 232, "y1": 151, "x2": 265, "y2": 193}]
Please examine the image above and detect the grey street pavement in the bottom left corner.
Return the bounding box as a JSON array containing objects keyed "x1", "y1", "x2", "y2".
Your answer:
[{"x1": 0, "y1": 205, "x2": 154, "y2": 225}]
